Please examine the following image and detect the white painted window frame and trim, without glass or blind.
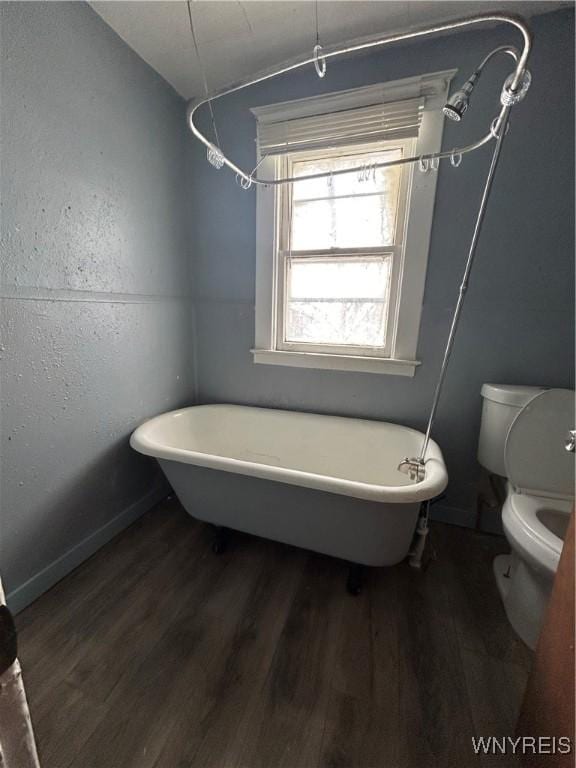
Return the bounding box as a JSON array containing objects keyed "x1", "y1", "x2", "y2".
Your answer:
[{"x1": 252, "y1": 70, "x2": 457, "y2": 376}]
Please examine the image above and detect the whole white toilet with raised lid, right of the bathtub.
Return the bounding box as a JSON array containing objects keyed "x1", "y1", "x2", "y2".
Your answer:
[{"x1": 478, "y1": 384, "x2": 575, "y2": 649}]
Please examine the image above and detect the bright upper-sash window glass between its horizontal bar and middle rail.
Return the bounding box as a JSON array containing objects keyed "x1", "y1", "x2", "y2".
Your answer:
[{"x1": 291, "y1": 195, "x2": 397, "y2": 251}]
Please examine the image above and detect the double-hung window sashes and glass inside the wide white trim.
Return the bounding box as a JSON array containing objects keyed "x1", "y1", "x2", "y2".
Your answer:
[{"x1": 276, "y1": 139, "x2": 414, "y2": 357}]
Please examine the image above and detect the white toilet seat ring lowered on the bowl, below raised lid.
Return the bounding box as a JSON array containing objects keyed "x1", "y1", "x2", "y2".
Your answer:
[{"x1": 502, "y1": 493, "x2": 573, "y2": 574}]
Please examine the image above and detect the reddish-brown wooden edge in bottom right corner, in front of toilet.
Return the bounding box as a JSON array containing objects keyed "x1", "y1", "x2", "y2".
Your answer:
[{"x1": 516, "y1": 511, "x2": 574, "y2": 768}]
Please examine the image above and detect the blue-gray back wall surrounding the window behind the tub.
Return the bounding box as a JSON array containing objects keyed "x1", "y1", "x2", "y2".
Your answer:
[{"x1": 188, "y1": 10, "x2": 574, "y2": 524}]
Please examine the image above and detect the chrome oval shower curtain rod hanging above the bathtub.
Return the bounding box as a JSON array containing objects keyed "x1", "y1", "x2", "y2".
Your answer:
[{"x1": 188, "y1": 13, "x2": 532, "y2": 186}]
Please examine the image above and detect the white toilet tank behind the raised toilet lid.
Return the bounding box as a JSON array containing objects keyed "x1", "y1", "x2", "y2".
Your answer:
[{"x1": 478, "y1": 384, "x2": 545, "y2": 477}]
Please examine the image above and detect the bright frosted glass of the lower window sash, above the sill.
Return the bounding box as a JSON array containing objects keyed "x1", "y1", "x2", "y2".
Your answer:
[{"x1": 285, "y1": 256, "x2": 391, "y2": 347}]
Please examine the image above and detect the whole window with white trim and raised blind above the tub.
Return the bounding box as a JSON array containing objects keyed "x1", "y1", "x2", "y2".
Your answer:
[{"x1": 254, "y1": 72, "x2": 454, "y2": 375}]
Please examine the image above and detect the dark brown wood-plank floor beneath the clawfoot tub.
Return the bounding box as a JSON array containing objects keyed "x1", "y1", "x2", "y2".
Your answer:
[{"x1": 17, "y1": 499, "x2": 531, "y2": 768}]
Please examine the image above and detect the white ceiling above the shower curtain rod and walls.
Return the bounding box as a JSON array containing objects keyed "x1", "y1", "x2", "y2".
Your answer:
[{"x1": 90, "y1": 0, "x2": 573, "y2": 99}]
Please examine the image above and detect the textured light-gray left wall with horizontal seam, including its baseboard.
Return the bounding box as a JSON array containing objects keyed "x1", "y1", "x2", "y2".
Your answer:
[{"x1": 0, "y1": 2, "x2": 194, "y2": 609}]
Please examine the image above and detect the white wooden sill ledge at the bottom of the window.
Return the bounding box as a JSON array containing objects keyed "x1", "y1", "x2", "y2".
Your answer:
[{"x1": 252, "y1": 349, "x2": 420, "y2": 376}]
